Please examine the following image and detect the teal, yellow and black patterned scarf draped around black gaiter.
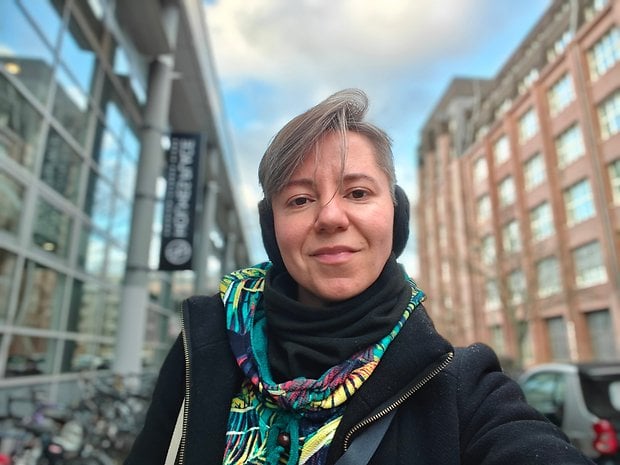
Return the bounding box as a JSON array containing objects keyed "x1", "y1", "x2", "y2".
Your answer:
[{"x1": 220, "y1": 262, "x2": 424, "y2": 465}]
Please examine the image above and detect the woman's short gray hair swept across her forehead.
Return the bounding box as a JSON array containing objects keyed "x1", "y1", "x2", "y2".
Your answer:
[{"x1": 258, "y1": 89, "x2": 396, "y2": 201}]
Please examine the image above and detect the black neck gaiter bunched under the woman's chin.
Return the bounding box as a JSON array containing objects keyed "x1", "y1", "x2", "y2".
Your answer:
[{"x1": 264, "y1": 255, "x2": 411, "y2": 382}]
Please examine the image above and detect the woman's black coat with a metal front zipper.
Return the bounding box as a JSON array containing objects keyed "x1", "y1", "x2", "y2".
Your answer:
[{"x1": 125, "y1": 297, "x2": 592, "y2": 465}]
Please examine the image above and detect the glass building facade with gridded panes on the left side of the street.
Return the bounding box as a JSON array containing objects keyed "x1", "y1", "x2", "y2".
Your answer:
[{"x1": 0, "y1": 0, "x2": 245, "y2": 388}]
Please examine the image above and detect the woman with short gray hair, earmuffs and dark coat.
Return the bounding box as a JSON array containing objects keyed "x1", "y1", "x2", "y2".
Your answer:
[{"x1": 125, "y1": 90, "x2": 591, "y2": 465}]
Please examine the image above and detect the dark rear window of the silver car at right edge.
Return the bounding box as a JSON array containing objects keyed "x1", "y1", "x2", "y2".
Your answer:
[{"x1": 580, "y1": 372, "x2": 620, "y2": 420}]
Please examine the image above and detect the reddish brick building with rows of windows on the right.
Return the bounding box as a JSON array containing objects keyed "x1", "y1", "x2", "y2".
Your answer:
[{"x1": 415, "y1": 0, "x2": 620, "y2": 366}]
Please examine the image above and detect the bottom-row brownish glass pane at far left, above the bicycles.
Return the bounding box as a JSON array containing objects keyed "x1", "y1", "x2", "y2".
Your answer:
[{"x1": 6, "y1": 335, "x2": 57, "y2": 378}]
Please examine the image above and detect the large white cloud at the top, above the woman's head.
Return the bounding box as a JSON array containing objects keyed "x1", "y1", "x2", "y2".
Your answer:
[{"x1": 207, "y1": 0, "x2": 492, "y2": 85}]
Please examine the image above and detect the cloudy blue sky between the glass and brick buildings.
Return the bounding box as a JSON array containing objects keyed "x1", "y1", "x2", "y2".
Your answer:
[{"x1": 204, "y1": 0, "x2": 550, "y2": 276}]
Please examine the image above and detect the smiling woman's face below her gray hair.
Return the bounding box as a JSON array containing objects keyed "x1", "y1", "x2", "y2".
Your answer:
[{"x1": 272, "y1": 132, "x2": 394, "y2": 304}]
